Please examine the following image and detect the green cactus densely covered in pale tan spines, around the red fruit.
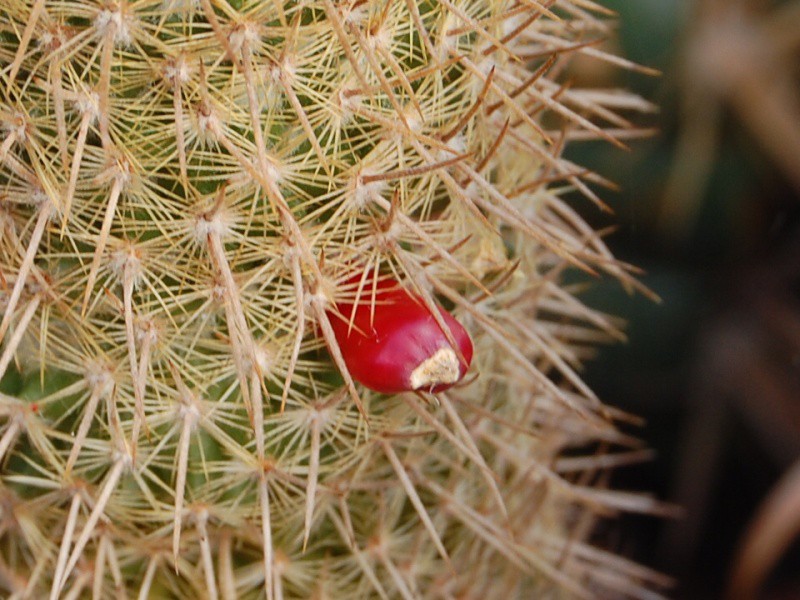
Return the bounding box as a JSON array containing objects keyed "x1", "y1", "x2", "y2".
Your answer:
[{"x1": 0, "y1": 0, "x2": 665, "y2": 600}]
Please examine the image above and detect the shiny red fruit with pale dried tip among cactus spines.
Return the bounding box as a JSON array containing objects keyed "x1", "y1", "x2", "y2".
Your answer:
[{"x1": 328, "y1": 277, "x2": 472, "y2": 394}]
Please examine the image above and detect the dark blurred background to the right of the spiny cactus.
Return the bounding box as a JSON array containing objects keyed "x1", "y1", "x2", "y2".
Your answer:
[{"x1": 568, "y1": 0, "x2": 800, "y2": 599}]
